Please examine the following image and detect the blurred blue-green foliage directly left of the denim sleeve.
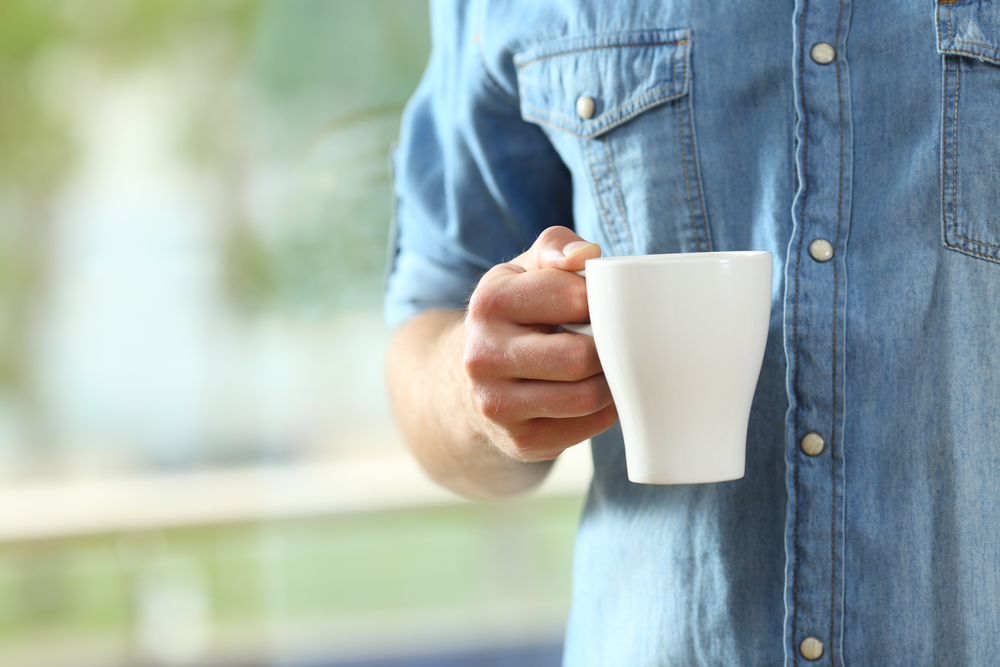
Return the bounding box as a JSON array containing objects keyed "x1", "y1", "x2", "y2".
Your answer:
[{"x1": 228, "y1": 0, "x2": 430, "y2": 316}]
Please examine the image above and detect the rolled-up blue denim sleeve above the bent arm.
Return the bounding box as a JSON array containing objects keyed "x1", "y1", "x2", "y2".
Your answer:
[{"x1": 385, "y1": 0, "x2": 572, "y2": 326}]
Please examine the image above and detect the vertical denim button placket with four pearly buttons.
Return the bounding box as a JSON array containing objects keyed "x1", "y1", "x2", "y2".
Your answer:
[{"x1": 785, "y1": 0, "x2": 852, "y2": 665}]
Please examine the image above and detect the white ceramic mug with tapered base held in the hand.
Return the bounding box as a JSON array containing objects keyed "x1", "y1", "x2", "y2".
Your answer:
[{"x1": 563, "y1": 251, "x2": 772, "y2": 484}]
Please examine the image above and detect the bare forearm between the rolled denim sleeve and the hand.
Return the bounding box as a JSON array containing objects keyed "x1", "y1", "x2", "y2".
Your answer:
[{"x1": 387, "y1": 310, "x2": 552, "y2": 498}]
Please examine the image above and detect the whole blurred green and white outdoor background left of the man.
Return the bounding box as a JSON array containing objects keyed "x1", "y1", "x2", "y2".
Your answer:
[{"x1": 0, "y1": 0, "x2": 586, "y2": 667}]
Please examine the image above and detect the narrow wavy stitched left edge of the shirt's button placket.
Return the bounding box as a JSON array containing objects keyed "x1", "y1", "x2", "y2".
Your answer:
[{"x1": 791, "y1": 0, "x2": 809, "y2": 667}]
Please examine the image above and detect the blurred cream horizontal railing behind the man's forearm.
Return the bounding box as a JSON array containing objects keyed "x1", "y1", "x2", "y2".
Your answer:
[{"x1": 0, "y1": 445, "x2": 592, "y2": 545}]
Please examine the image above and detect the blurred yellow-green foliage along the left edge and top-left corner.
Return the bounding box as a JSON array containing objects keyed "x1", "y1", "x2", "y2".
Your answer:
[{"x1": 0, "y1": 0, "x2": 260, "y2": 394}]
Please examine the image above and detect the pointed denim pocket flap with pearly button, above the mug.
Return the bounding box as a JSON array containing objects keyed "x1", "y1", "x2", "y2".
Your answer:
[{"x1": 514, "y1": 30, "x2": 691, "y2": 138}]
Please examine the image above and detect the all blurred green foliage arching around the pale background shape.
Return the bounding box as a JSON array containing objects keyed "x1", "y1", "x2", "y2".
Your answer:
[{"x1": 0, "y1": 0, "x2": 430, "y2": 394}]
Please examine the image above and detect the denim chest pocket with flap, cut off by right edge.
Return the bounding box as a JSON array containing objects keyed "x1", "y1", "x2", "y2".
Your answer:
[{"x1": 937, "y1": 0, "x2": 1000, "y2": 262}]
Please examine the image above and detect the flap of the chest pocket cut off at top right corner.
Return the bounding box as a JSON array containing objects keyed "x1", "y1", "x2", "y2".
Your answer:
[{"x1": 937, "y1": 0, "x2": 1000, "y2": 64}]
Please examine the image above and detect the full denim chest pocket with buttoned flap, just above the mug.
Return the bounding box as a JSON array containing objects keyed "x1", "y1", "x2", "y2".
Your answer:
[{"x1": 514, "y1": 30, "x2": 712, "y2": 255}]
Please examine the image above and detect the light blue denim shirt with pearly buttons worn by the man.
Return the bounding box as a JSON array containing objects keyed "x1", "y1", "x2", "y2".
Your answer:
[{"x1": 386, "y1": 0, "x2": 1000, "y2": 667}]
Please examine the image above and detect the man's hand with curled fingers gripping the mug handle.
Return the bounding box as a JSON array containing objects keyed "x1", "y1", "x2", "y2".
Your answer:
[{"x1": 464, "y1": 227, "x2": 618, "y2": 461}]
